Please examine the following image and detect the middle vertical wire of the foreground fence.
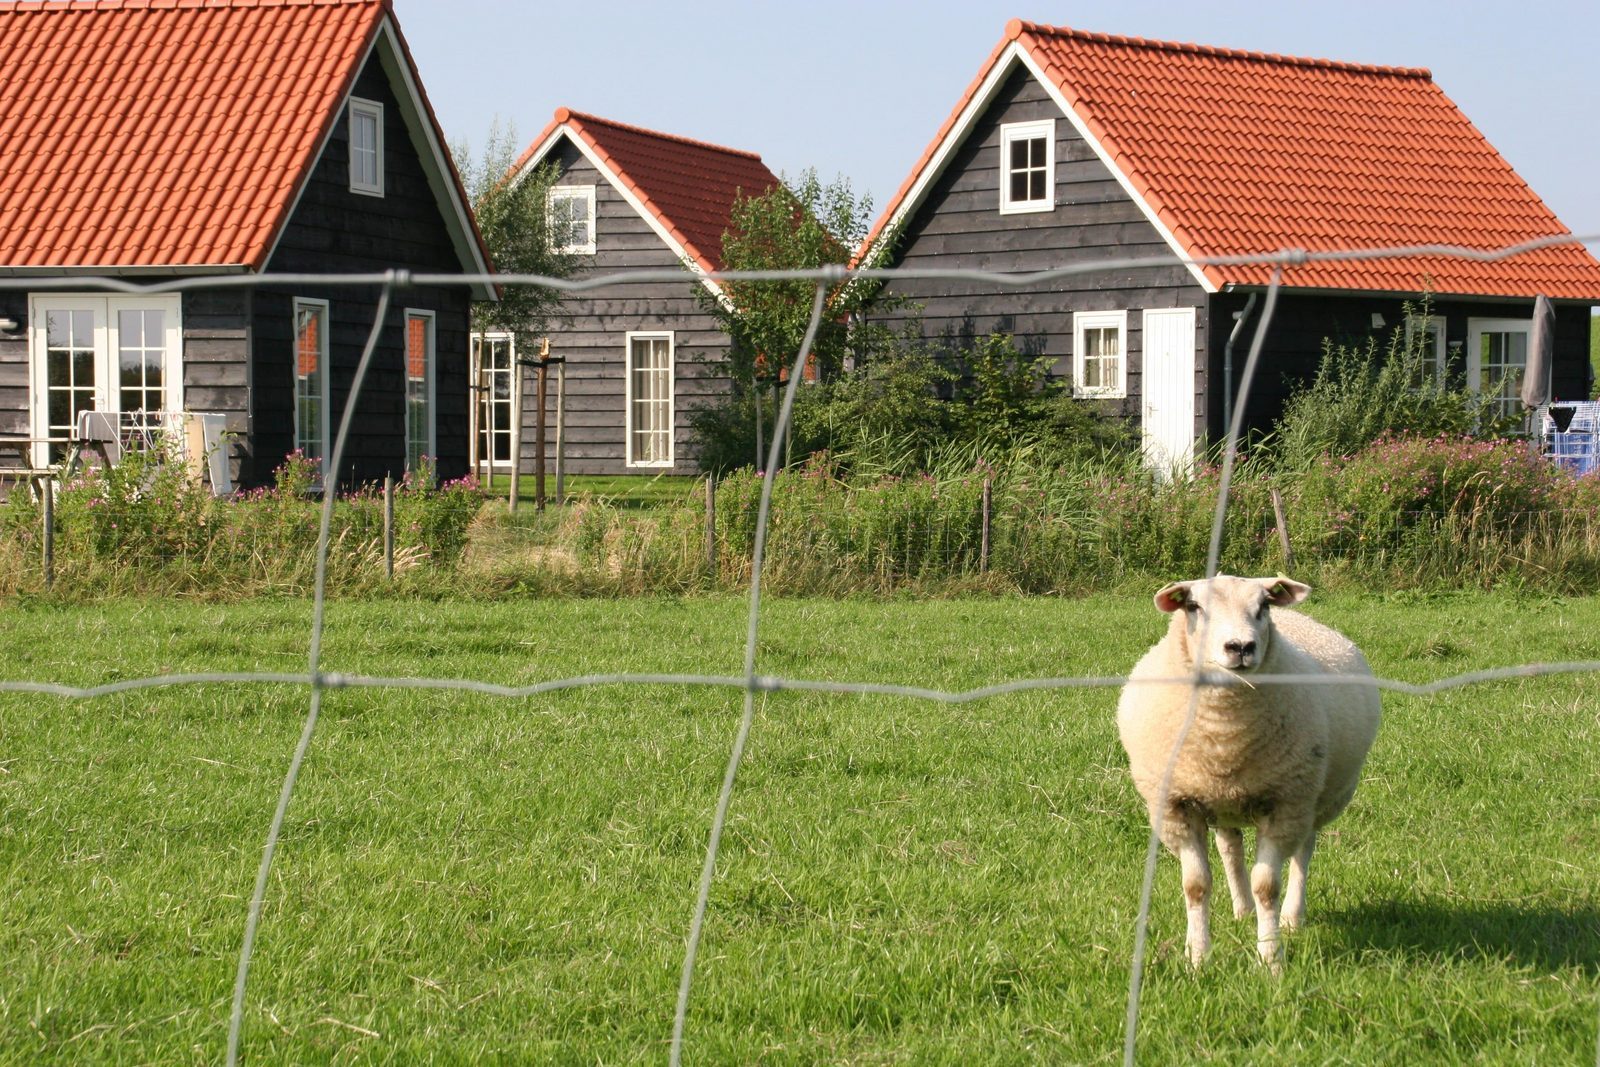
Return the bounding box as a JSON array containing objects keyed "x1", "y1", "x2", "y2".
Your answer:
[{"x1": 670, "y1": 280, "x2": 827, "y2": 1067}]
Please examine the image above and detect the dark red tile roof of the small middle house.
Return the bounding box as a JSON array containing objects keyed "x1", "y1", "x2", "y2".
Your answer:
[{"x1": 514, "y1": 107, "x2": 779, "y2": 270}]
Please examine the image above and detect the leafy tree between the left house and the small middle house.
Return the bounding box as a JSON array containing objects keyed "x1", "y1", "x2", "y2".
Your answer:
[{"x1": 451, "y1": 120, "x2": 578, "y2": 349}]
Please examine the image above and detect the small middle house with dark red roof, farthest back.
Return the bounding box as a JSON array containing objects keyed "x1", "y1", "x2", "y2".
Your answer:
[{"x1": 475, "y1": 107, "x2": 779, "y2": 474}]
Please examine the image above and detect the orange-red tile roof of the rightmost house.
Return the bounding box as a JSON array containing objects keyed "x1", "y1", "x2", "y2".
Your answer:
[{"x1": 867, "y1": 19, "x2": 1600, "y2": 301}]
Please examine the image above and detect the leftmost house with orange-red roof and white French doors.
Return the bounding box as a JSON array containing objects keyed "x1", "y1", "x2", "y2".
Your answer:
[{"x1": 0, "y1": 0, "x2": 494, "y2": 486}]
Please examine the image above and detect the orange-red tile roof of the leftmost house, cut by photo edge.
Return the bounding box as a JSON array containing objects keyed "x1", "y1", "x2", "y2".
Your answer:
[{"x1": 0, "y1": 0, "x2": 482, "y2": 269}]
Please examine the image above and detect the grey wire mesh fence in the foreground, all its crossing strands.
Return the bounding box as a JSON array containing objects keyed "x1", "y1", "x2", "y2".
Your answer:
[{"x1": 0, "y1": 235, "x2": 1600, "y2": 1067}]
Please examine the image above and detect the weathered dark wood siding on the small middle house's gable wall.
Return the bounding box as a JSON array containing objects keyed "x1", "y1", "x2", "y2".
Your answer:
[{"x1": 522, "y1": 139, "x2": 728, "y2": 474}]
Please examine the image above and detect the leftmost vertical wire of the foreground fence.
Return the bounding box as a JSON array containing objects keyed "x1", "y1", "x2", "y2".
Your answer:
[{"x1": 227, "y1": 270, "x2": 402, "y2": 1067}]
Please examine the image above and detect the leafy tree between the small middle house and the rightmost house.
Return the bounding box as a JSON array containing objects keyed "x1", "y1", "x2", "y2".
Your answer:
[{"x1": 694, "y1": 170, "x2": 894, "y2": 386}]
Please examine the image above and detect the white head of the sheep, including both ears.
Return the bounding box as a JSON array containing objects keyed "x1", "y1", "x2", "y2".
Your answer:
[{"x1": 1155, "y1": 574, "x2": 1310, "y2": 670}]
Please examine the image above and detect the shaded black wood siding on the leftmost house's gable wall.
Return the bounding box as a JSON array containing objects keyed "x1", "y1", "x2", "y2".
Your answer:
[{"x1": 246, "y1": 54, "x2": 469, "y2": 485}]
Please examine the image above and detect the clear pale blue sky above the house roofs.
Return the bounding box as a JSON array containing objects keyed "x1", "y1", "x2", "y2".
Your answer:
[{"x1": 395, "y1": 0, "x2": 1600, "y2": 244}]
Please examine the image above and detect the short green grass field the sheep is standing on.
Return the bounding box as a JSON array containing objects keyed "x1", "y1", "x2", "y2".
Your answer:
[{"x1": 0, "y1": 593, "x2": 1600, "y2": 1064}]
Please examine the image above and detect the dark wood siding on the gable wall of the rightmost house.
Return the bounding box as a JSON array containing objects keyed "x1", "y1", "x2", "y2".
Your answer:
[{"x1": 882, "y1": 66, "x2": 1210, "y2": 429}]
